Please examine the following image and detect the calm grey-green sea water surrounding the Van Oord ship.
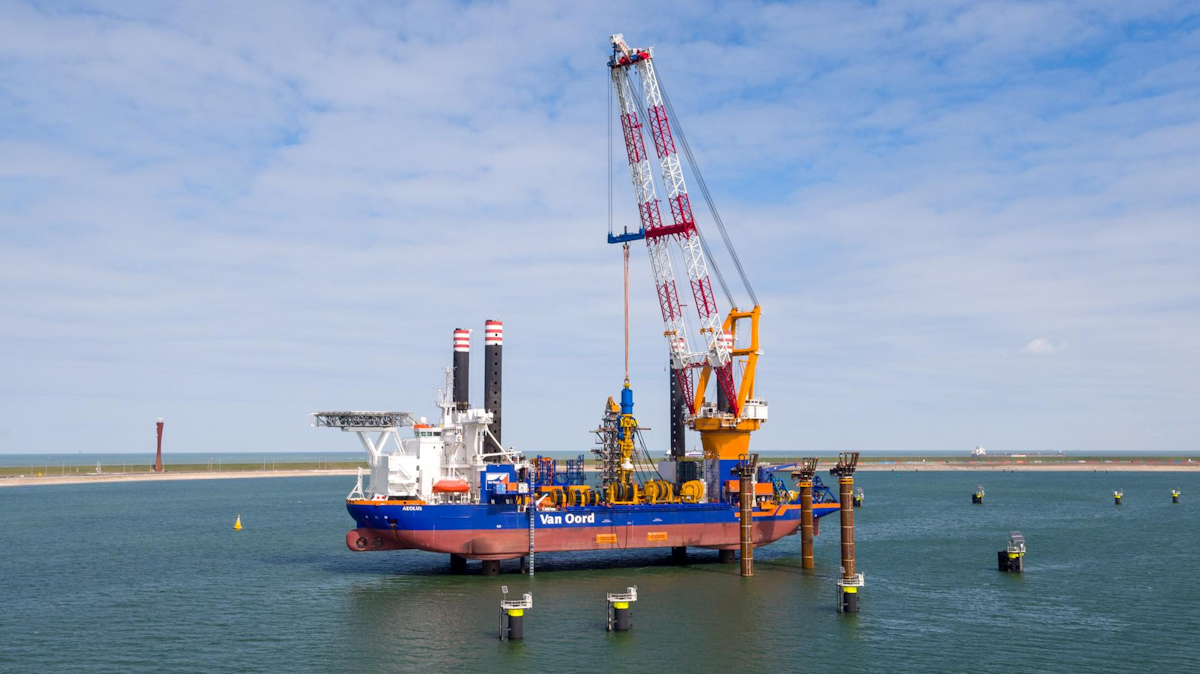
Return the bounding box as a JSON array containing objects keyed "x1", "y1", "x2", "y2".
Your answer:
[{"x1": 0, "y1": 473, "x2": 1200, "y2": 673}]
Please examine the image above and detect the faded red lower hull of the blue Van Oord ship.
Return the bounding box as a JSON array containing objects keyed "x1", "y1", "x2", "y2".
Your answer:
[{"x1": 346, "y1": 518, "x2": 800, "y2": 560}]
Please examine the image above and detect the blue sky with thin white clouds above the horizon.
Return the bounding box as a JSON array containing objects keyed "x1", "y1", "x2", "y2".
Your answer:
[{"x1": 0, "y1": 0, "x2": 1200, "y2": 452}]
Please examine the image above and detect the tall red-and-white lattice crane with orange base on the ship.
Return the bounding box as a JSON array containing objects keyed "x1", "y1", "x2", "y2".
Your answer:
[{"x1": 608, "y1": 34, "x2": 767, "y2": 499}]
